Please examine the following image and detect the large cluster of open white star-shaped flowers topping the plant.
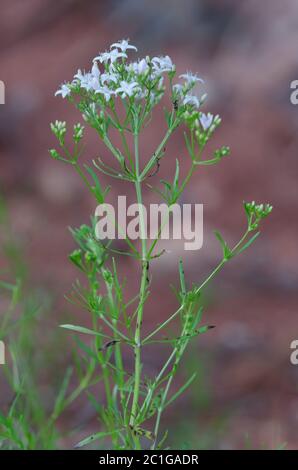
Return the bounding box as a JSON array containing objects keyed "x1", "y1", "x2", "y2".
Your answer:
[{"x1": 55, "y1": 39, "x2": 208, "y2": 112}]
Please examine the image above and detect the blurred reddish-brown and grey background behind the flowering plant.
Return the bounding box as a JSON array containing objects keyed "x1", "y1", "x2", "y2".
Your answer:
[{"x1": 0, "y1": 0, "x2": 298, "y2": 449}]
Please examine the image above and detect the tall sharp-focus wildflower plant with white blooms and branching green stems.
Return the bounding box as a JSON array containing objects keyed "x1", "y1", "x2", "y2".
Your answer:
[{"x1": 50, "y1": 40, "x2": 272, "y2": 449}]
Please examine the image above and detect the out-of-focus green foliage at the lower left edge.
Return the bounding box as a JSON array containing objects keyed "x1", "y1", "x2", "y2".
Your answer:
[{"x1": 0, "y1": 197, "x2": 96, "y2": 450}]
